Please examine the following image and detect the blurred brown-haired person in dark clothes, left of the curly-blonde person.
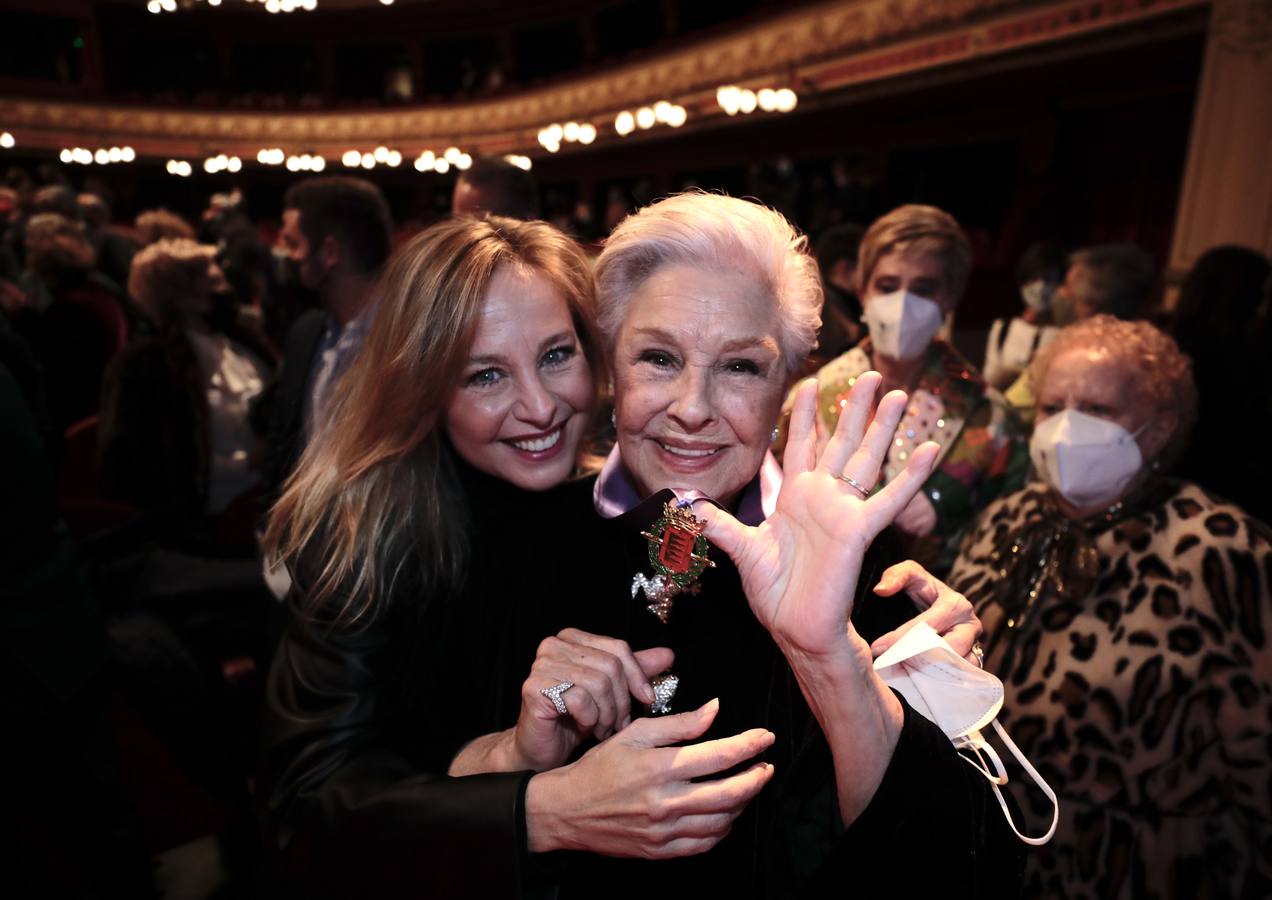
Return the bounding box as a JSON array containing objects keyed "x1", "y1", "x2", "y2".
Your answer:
[{"x1": 11, "y1": 212, "x2": 128, "y2": 432}]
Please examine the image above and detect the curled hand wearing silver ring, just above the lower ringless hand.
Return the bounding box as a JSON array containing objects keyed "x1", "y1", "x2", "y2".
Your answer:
[{"x1": 511, "y1": 628, "x2": 674, "y2": 772}]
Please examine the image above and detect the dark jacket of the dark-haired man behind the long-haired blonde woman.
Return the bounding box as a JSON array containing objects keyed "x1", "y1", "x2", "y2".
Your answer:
[{"x1": 252, "y1": 309, "x2": 331, "y2": 511}]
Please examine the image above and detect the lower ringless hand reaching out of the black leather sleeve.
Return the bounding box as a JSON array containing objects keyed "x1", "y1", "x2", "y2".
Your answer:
[{"x1": 525, "y1": 700, "x2": 773, "y2": 859}]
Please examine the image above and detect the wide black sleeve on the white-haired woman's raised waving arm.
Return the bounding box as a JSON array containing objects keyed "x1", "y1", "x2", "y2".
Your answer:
[{"x1": 772, "y1": 694, "x2": 1024, "y2": 900}]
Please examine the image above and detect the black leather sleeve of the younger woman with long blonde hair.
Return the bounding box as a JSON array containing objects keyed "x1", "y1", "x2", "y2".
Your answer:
[{"x1": 261, "y1": 594, "x2": 532, "y2": 897}]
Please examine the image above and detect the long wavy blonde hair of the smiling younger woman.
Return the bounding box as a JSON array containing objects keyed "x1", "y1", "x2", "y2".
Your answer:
[{"x1": 265, "y1": 216, "x2": 602, "y2": 627}]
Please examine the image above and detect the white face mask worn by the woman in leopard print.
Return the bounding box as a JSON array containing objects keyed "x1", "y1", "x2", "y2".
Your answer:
[{"x1": 1029, "y1": 409, "x2": 1147, "y2": 510}]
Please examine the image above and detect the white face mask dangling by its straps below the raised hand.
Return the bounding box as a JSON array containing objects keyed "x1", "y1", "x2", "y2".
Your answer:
[{"x1": 874, "y1": 622, "x2": 1060, "y2": 847}]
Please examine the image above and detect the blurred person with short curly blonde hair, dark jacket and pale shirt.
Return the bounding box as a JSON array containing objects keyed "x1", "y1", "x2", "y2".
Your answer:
[{"x1": 98, "y1": 238, "x2": 268, "y2": 536}]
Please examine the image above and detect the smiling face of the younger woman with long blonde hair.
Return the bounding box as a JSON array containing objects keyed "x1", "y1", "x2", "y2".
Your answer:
[{"x1": 444, "y1": 266, "x2": 595, "y2": 491}]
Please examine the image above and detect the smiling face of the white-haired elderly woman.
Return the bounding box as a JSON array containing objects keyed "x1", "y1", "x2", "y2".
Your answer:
[{"x1": 613, "y1": 266, "x2": 786, "y2": 505}]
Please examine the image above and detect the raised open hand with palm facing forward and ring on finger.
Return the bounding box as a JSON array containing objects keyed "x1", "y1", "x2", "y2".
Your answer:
[{"x1": 696, "y1": 372, "x2": 939, "y2": 662}]
